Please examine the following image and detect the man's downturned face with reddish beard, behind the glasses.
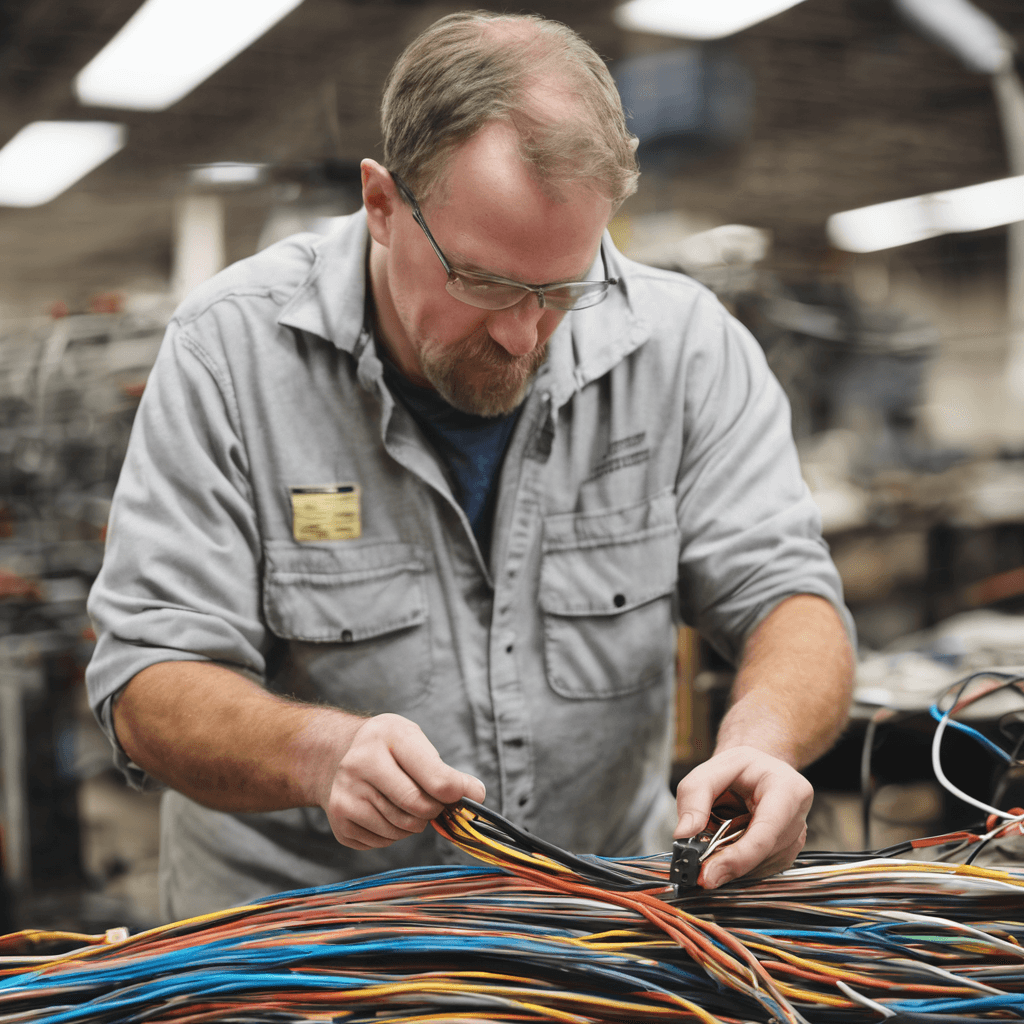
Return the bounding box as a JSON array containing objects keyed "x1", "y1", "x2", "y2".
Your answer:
[{"x1": 368, "y1": 123, "x2": 611, "y2": 416}]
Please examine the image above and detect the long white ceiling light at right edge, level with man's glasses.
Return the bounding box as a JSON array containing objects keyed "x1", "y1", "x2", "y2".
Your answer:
[{"x1": 826, "y1": 175, "x2": 1024, "y2": 253}]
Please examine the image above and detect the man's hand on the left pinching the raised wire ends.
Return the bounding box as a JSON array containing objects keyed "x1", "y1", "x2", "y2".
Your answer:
[{"x1": 322, "y1": 715, "x2": 485, "y2": 850}]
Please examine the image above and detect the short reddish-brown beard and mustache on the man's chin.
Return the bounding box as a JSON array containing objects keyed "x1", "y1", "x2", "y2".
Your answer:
[{"x1": 419, "y1": 331, "x2": 548, "y2": 417}]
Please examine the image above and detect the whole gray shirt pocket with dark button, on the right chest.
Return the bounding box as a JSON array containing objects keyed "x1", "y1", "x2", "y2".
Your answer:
[{"x1": 540, "y1": 492, "x2": 679, "y2": 700}]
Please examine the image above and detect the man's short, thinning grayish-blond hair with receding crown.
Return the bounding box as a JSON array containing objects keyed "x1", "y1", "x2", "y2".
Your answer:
[{"x1": 381, "y1": 11, "x2": 639, "y2": 208}]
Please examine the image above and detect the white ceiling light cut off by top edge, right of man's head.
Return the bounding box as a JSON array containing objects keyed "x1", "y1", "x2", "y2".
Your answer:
[{"x1": 612, "y1": 0, "x2": 802, "y2": 39}]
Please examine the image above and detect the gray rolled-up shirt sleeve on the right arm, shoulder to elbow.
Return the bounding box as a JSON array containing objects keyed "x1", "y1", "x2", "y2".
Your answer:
[{"x1": 676, "y1": 296, "x2": 855, "y2": 663}]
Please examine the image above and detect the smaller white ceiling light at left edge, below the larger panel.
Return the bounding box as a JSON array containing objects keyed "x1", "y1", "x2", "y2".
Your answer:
[{"x1": 0, "y1": 121, "x2": 126, "y2": 206}]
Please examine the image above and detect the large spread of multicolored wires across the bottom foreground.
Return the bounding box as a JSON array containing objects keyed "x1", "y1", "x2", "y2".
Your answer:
[{"x1": 0, "y1": 801, "x2": 1024, "y2": 1024}]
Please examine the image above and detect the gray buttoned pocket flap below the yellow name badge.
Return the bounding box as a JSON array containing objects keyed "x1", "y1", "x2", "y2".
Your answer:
[{"x1": 263, "y1": 542, "x2": 427, "y2": 643}]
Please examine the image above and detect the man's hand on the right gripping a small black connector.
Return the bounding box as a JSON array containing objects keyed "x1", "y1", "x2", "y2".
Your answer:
[{"x1": 675, "y1": 746, "x2": 814, "y2": 889}]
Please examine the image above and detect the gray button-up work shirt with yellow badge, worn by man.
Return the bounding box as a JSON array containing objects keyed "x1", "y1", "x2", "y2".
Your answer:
[{"x1": 87, "y1": 213, "x2": 842, "y2": 916}]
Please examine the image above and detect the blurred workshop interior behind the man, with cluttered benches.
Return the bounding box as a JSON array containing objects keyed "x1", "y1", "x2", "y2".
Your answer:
[{"x1": 0, "y1": 0, "x2": 1024, "y2": 933}]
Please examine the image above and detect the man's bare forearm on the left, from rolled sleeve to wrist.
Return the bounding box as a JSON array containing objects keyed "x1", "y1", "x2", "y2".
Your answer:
[{"x1": 114, "y1": 662, "x2": 367, "y2": 812}]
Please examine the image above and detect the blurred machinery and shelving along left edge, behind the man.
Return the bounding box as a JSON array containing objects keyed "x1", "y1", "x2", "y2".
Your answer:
[{"x1": 0, "y1": 295, "x2": 163, "y2": 925}]
